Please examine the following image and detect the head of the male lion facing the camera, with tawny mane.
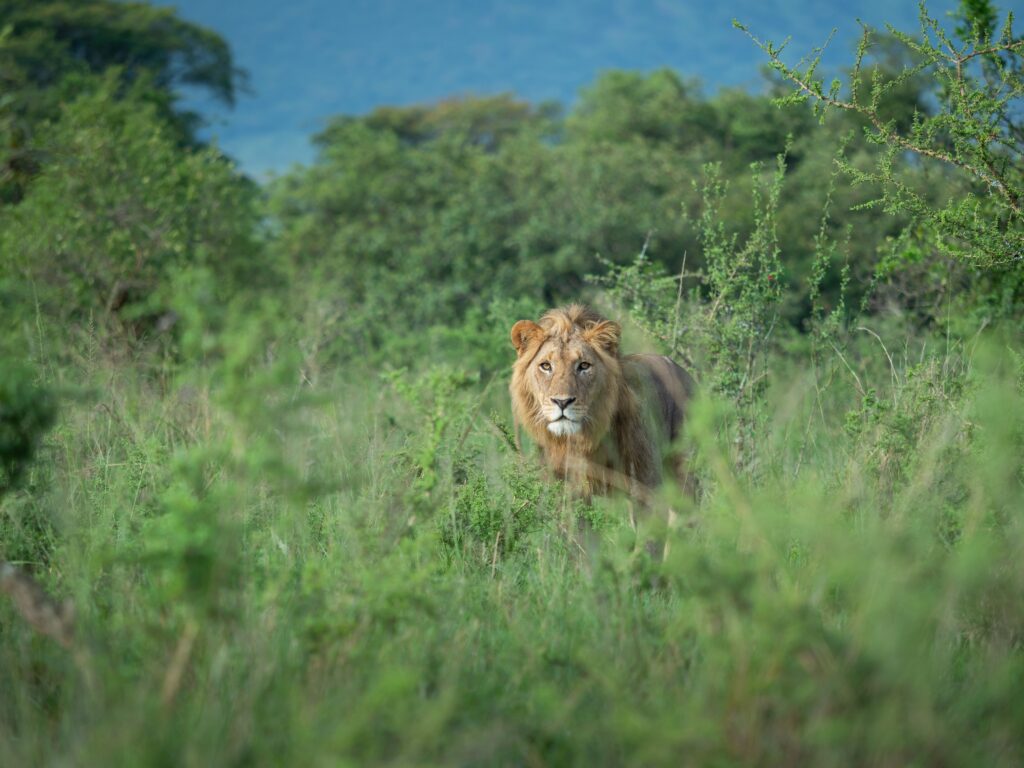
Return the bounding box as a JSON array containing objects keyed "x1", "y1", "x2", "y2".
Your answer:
[{"x1": 510, "y1": 304, "x2": 623, "y2": 450}]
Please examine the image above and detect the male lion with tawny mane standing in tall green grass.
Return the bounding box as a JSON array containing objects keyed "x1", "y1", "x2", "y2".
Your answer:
[{"x1": 509, "y1": 304, "x2": 693, "y2": 498}]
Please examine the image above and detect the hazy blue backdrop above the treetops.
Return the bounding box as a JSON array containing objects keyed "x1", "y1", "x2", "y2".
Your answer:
[{"x1": 174, "y1": 0, "x2": 966, "y2": 176}]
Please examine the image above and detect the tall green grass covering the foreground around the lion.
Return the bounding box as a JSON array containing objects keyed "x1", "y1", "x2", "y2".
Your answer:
[{"x1": 0, "y1": 327, "x2": 1024, "y2": 766}]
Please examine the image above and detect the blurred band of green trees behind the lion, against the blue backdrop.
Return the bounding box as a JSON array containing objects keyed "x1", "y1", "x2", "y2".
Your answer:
[{"x1": 270, "y1": 72, "x2": 864, "y2": 365}]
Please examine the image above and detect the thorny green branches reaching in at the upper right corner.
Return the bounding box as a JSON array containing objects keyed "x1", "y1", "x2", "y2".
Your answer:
[{"x1": 737, "y1": 3, "x2": 1024, "y2": 266}]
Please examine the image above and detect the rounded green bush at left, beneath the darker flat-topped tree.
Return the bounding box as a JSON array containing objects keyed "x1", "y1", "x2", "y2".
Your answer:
[{"x1": 0, "y1": 73, "x2": 262, "y2": 348}]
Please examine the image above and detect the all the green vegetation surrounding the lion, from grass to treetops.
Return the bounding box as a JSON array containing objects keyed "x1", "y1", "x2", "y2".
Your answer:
[{"x1": 0, "y1": 0, "x2": 1024, "y2": 766}]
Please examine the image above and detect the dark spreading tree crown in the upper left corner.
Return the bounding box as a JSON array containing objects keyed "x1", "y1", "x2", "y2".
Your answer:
[{"x1": 0, "y1": 0, "x2": 245, "y2": 209}]
